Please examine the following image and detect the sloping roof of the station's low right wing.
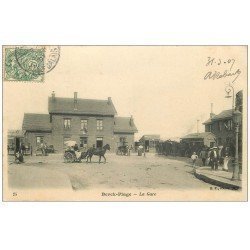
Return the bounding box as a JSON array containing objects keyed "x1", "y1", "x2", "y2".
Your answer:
[{"x1": 114, "y1": 117, "x2": 138, "y2": 133}]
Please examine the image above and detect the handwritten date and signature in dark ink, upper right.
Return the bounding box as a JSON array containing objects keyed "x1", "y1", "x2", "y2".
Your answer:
[{"x1": 204, "y1": 57, "x2": 241, "y2": 83}]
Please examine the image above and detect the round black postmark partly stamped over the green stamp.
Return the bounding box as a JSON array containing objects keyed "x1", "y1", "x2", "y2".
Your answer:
[{"x1": 14, "y1": 46, "x2": 60, "y2": 76}]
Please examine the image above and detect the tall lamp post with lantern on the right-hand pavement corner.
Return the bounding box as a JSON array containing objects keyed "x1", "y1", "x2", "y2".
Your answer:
[{"x1": 232, "y1": 110, "x2": 242, "y2": 181}]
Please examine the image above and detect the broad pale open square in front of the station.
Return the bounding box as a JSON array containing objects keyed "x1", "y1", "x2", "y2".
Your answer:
[{"x1": 6, "y1": 154, "x2": 216, "y2": 190}]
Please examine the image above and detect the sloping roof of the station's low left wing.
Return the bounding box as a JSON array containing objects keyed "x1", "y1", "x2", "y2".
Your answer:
[{"x1": 23, "y1": 113, "x2": 51, "y2": 131}]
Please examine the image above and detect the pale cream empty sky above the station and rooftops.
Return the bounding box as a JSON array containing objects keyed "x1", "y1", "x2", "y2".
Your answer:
[{"x1": 3, "y1": 46, "x2": 247, "y2": 139}]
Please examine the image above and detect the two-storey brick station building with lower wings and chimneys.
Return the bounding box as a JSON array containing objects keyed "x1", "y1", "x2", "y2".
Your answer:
[{"x1": 22, "y1": 92, "x2": 138, "y2": 152}]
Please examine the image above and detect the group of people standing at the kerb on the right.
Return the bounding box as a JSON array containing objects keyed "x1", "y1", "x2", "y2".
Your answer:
[{"x1": 191, "y1": 146, "x2": 233, "y2": 171}]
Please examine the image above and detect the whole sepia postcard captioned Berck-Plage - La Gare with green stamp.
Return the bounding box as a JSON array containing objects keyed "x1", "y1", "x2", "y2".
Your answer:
[{"x1": 2, "y1": 45, "x2": 248, "y2": 201}]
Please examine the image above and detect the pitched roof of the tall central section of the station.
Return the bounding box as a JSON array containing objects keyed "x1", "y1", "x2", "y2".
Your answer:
[{"x1": 49, "y1": 97, "x2": 117, "y2": 115}]
